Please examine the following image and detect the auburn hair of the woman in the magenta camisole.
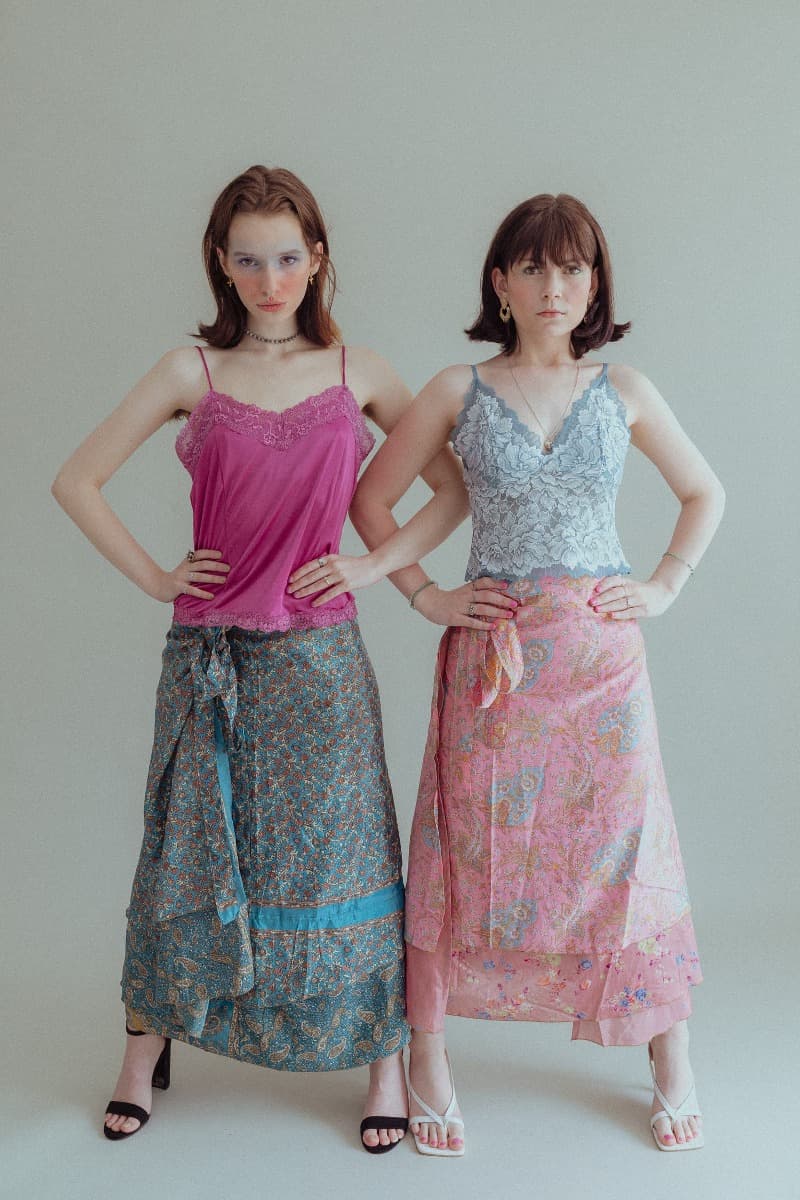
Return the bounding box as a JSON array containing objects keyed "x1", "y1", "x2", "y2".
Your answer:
[{"x1": 194, "y1": 166, "x2": 341, "y2": 350}]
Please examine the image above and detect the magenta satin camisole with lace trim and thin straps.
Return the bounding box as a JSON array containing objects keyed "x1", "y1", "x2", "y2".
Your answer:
[{"x1": 174, "y1": 347, "x2": 374, "y2": 631}]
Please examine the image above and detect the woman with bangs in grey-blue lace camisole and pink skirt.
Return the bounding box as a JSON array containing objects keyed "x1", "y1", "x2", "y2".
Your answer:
[{"x1": 293, "y1": 196, "x2": 724, "y2": 1154}]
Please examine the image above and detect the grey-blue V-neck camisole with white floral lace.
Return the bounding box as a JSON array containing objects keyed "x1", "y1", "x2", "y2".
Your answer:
[{"x1": 450, "y1": 364, "x2": 631, "y2": 583}]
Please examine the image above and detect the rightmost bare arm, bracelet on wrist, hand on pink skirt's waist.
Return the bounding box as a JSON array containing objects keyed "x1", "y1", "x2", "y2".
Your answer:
[{"x1": 596, "y1": 367, "x2": 724, "y2": 618}]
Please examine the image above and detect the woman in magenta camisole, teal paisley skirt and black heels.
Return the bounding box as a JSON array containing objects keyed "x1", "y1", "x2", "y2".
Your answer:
[{"x1": 53, "y1": 166, "x2": 465, "y2": 1153}]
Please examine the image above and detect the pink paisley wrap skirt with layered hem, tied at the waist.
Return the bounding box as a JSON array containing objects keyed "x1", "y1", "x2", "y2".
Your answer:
[{"x1": 405, "y1": 577, "x2": 702, "y2": 1045}]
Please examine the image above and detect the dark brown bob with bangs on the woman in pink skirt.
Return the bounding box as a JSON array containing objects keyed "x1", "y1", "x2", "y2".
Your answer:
[{"x1": 464, "y1": 194, "x2": 631, "y2": 359}]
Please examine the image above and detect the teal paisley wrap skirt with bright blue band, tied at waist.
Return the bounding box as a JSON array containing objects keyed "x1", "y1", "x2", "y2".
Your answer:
[{"x1": 122, "y1": 622, "x2": 409, "y2": 1070}]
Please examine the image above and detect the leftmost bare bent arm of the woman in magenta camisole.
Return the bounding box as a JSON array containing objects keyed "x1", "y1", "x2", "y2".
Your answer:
[{"x1": 52, "y1": 349, "x2": 228, "y2": 601}]
